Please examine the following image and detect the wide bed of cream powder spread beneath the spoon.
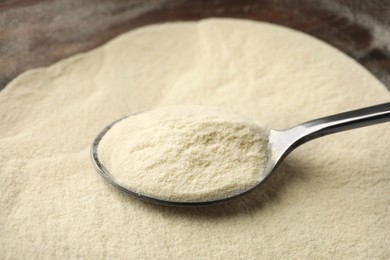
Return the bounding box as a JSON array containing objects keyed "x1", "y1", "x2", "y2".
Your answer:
[{"x1": 0, "y1": 19, "x2": 390, "y2": 259}]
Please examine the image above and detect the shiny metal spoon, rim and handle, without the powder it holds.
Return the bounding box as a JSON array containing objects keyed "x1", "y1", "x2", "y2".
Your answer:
[{"x1": 91, "y1": 102, "x2": 390, "y2": 207}]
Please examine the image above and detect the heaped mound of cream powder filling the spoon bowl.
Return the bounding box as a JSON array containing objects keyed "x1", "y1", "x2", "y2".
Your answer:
[{"x1": 98, "y1": 106, "x2": 268, "y2": 202}]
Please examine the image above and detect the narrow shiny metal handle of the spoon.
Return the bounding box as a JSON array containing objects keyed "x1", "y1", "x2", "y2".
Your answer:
[{"x1": 290, "y1": 102, "x2": 390, "y2": 147}]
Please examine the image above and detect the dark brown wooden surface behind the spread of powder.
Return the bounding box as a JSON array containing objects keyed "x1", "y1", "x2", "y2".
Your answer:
[{"x1": 0, "y1": 0, "x2": 390, "y2": 89}]
